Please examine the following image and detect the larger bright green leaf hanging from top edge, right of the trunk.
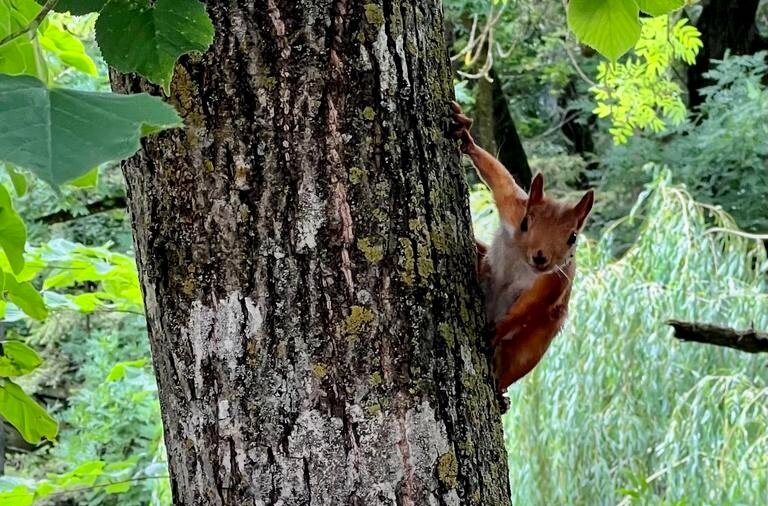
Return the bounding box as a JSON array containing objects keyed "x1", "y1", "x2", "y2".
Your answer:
[{"x1": 568, "y1": 0, "x2": 640, "y2": 60}]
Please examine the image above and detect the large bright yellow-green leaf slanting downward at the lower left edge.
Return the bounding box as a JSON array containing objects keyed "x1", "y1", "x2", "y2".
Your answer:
[{"x1": 0, "y1": 379, "x2": 59, "y2": 444}]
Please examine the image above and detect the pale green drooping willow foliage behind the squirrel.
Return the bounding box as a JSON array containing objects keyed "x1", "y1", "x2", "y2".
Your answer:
[{"x1": 472, "y1": 171, "x2": 768, "y2": 505}]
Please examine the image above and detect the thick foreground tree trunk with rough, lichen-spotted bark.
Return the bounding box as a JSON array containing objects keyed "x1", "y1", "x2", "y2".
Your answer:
[{"x1": 113, "y1": 0, "x2": 509, "y2": 506}]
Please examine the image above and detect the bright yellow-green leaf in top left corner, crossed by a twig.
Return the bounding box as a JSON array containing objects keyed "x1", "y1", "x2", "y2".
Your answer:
[{"x1": 0, "y1": 0, "x2": 48, "y2": 81}]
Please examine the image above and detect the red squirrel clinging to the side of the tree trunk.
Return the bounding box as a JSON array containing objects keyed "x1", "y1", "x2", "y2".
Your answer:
[{"x1": 452, "y1": 102, "x2": 594, "y2": 392}]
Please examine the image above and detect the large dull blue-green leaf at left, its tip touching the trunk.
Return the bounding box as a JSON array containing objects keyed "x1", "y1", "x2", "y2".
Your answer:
[{"x1": 0, "y1": 75, "x2": 182, "y2": 185}]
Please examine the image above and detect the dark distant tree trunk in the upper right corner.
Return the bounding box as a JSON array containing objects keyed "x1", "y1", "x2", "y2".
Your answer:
[{"x1": 688, "y1": 0, "x2": 768, "y2": 107}]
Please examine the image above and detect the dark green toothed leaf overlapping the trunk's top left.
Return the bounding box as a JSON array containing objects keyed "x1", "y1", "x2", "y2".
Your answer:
[{"x1": 96, "y1": 0, "x2": 213, "y2": 95}]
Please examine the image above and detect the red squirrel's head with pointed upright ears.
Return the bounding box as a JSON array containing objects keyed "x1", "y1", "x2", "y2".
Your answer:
[{"x1": 510, "y1": 174, "x2": 594, "y2": 273}]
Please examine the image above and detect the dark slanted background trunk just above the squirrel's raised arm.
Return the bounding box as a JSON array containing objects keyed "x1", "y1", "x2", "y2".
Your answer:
[{"x1": 472, "y1": 69, "x2": 532, "y2": 190}]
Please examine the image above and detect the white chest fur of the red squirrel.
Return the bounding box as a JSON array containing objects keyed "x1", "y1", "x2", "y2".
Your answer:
[{"x1": 483, "y1": 231, "x2": 537, "y2": 323}]
